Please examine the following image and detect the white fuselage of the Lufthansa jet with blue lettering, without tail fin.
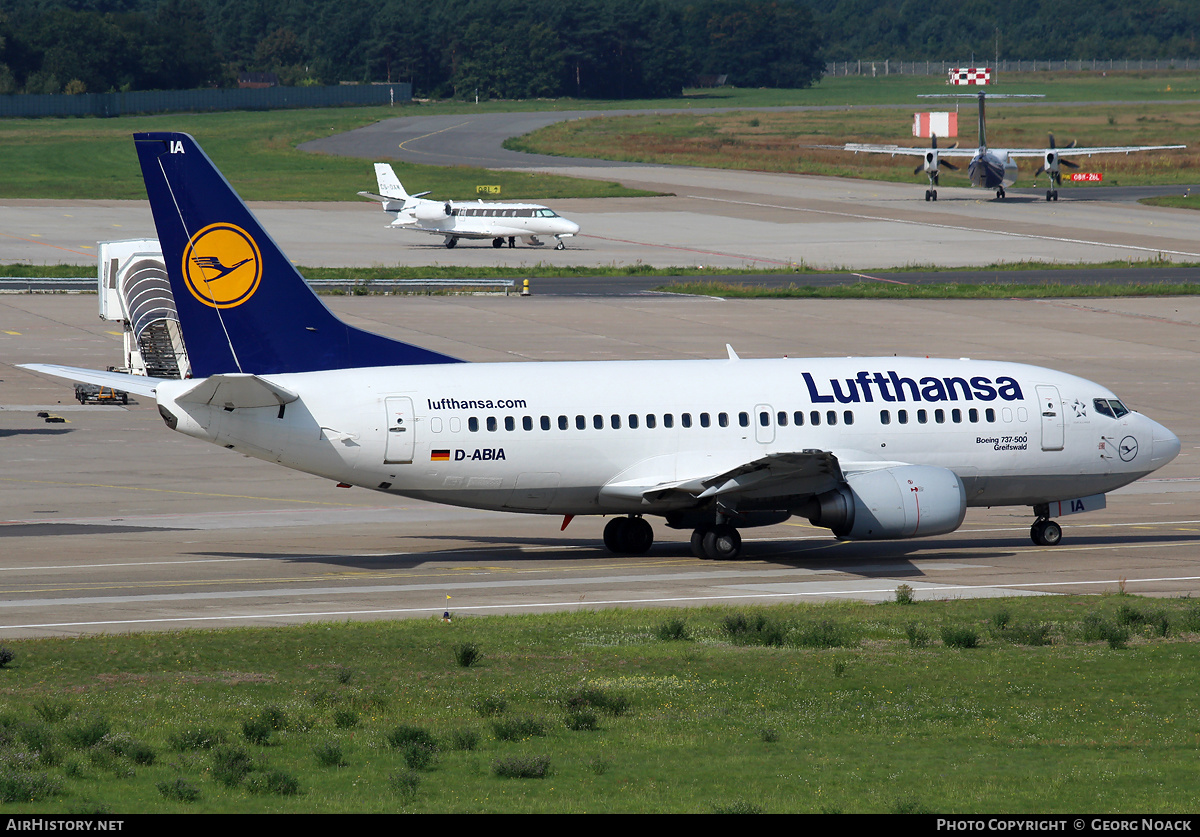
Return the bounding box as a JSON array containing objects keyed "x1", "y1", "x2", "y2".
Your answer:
[{"x1": 156, "y1": 357, "x2": 1180, "y2": 514}]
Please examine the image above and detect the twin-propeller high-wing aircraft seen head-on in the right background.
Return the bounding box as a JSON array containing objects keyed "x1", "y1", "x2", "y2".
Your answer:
[{"x1": 840, "y1": 90, "x2": 1187, "y2": 200}]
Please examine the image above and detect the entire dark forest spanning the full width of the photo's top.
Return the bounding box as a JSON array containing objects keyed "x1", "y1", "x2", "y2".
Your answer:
[{"x1": 0, "y1": 0, "x2": 1200, "y2": 98}]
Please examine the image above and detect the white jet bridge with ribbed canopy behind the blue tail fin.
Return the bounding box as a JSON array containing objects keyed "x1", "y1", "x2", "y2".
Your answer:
[{"x1": 97, "y1": 239, "x2": 191, "y2": 378}]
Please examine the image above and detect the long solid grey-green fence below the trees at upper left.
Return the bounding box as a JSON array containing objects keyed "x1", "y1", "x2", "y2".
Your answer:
[{"x1": 0, "y1": 82, "x2": 413, "y2": 118}]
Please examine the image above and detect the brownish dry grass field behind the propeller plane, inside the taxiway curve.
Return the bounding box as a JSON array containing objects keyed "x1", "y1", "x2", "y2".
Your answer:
[{"x1": 505, "y1": 72, "x2": 1200, "y2": 188}]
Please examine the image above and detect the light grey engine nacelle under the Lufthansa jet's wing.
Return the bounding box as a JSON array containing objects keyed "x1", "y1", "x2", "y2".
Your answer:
[{"x1": 804, "y1": 465, "x2": 967, "y2": 541}]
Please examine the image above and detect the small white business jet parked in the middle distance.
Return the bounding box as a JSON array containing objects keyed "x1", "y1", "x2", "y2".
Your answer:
[{"x1": 359, "y1": 163, "x2": 580, "y2": 249}]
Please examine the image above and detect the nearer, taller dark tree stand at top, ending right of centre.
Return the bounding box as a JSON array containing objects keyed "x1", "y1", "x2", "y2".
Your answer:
[{"x1": 0, "y1": 0, "x2": 824, "y2": 98}]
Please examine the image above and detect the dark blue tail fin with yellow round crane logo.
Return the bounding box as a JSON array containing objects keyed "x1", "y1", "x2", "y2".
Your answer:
[{"x1": 133, "y1": 133, "x2": 458, "y2": 377}]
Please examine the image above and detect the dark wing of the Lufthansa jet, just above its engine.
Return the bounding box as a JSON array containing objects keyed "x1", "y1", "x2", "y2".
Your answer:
[{"x1": 600, "y1": 450, "x2": 845, "y2": 505}]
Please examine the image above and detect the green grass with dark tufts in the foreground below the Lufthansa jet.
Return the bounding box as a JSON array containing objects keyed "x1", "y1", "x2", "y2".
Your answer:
[{"x1": 0, "y1": 595, "x2": 1200, "y2": 814}]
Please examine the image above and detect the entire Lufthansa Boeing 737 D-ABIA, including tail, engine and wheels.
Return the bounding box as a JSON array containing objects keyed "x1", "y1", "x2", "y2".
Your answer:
[{"x1": 24, "y1": 133, "x2": 1180, "y2": 559}]
